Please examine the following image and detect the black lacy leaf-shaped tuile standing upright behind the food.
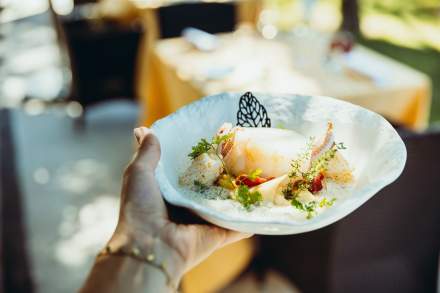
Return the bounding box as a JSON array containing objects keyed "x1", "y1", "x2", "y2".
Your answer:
[{"x1": 237, "y1": 92, "x2": 270, "y2": 127}]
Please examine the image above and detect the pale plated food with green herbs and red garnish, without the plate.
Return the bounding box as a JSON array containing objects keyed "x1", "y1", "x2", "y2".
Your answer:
[{"x1": 179, "y1": 122, "x2": 354, "y2": 219}]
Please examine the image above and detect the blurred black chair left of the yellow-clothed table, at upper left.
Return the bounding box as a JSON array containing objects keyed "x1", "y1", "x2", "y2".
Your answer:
[{"x1": 51, "y1": 4, "x2": 143, "y2": 126}]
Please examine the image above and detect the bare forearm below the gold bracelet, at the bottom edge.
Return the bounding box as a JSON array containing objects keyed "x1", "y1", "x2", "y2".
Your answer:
[{"x1": 80, "y1": 255, "x2": 174, "y2": 293}]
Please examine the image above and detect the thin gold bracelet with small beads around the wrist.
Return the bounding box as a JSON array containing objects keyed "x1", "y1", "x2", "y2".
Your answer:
[{"x1": 96, "y1": 245, "x2": 178, "y2": 292}]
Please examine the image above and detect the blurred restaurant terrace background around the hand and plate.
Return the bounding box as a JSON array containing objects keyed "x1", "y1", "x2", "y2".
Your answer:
[{"x1": 0, "y1": 0, "x2": 440, "y2": 292}]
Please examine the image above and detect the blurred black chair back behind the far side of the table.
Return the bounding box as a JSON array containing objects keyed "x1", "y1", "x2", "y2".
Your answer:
[{"x1": 157, "y1": 2, "x2": 238, "y2": 38}]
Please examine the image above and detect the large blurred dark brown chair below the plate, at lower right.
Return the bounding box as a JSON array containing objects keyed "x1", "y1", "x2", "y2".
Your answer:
[{"x1": 255, "y1": 132, "x2": 440, "y2": 293}]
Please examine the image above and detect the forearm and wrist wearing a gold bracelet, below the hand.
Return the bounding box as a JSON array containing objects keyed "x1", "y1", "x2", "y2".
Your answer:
[{"x1": 81, "y1": 224, "x2": 184, "y2": 293}]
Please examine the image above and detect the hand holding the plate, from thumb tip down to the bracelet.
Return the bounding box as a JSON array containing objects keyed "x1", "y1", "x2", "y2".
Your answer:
[{"x1": 109, "y1": 127, "x2": 252, "y2": 284}]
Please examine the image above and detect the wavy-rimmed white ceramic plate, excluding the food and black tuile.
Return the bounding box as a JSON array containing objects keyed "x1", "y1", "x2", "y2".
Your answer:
[{"x1": 152, "y1": 93, "x2": 406, "y2": 235}]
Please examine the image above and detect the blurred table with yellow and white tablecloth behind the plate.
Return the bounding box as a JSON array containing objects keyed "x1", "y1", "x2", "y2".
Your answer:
[{"x1": 142, "y1": 32, "x2": 431, "y2": 130}]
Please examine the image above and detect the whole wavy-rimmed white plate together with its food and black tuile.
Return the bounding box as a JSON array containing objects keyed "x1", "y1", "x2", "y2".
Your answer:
[{"x1": 152, "y1": 93, "x2": 406, "y2": 235}]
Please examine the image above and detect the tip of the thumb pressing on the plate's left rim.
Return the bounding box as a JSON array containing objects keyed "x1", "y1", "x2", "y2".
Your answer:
[{"x1": 133, "y1": 127, "x2": 160, "y2": 170}]
